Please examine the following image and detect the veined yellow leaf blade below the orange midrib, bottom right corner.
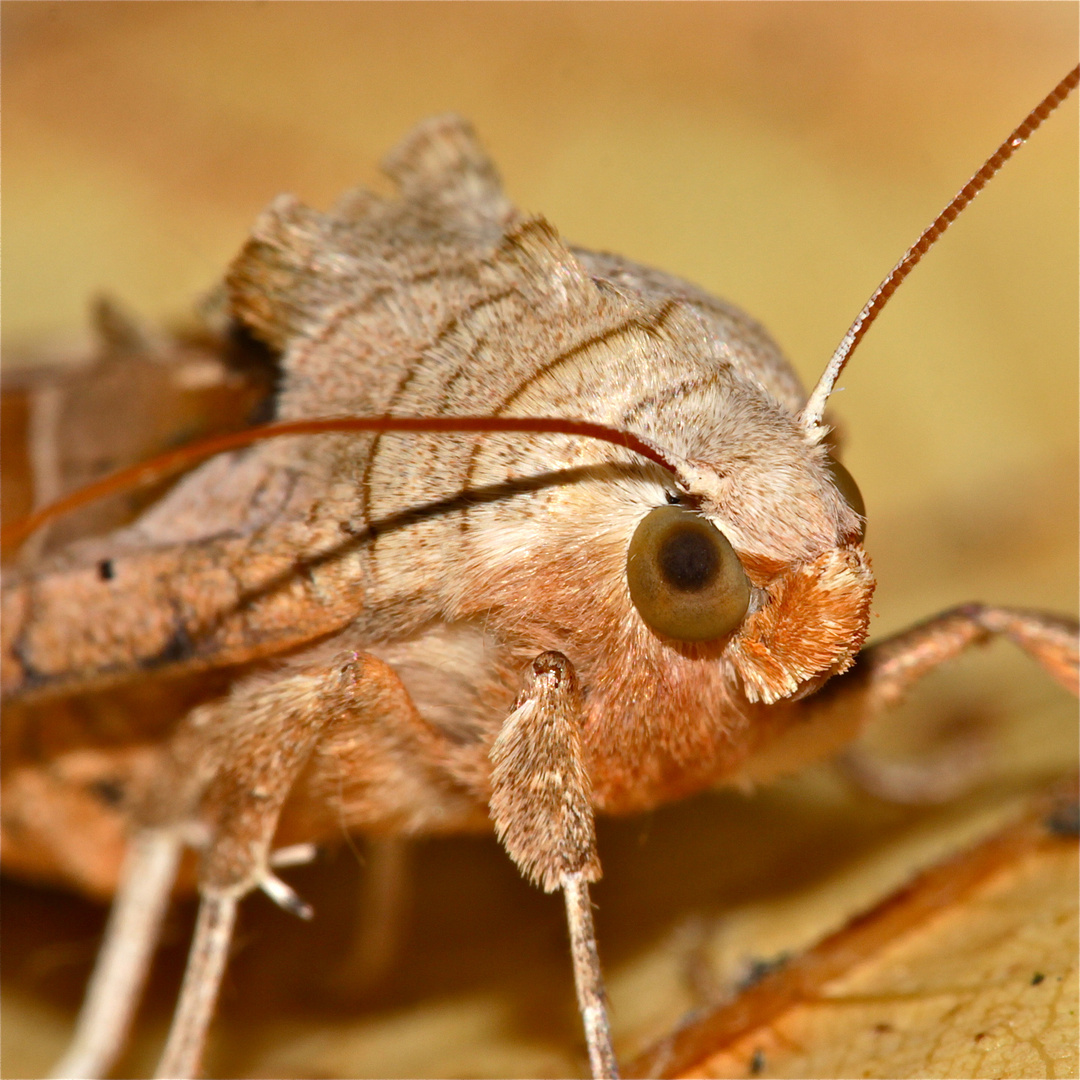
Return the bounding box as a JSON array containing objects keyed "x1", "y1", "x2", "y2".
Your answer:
[{"x1": 685, "y1": 845, "x2": 1080, "y2": 1077}]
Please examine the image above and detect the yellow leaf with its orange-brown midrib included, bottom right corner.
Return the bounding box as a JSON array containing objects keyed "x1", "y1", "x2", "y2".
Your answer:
[{"x1": 627, "y1": 786, "x2": 1080, "y2": 1077}]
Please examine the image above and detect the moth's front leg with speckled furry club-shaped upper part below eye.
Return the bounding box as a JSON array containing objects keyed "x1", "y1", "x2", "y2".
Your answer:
[{"x1": 489, "y1": 652, "x2": 619, "y2": 1078}]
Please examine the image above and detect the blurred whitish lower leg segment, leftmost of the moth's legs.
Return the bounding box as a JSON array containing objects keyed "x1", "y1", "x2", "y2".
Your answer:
[{"x1": 52, "y1": 829, "x2": 183, "y2": 1080}]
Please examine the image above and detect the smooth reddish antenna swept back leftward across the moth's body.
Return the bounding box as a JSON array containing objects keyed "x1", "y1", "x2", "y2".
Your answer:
[{"x1": 0, "y1": 416, "x2": 676, "y2": 549}]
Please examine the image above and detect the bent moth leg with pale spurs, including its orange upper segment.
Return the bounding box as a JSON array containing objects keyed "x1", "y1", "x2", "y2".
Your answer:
[{"x1": 158, "y1": 652, "x2": 472, "y2": 1077}]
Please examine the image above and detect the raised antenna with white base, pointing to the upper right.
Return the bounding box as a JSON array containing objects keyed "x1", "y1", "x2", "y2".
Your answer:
[{"x1": 799, "y1": 65, "x2": 1080, "y2": 429}]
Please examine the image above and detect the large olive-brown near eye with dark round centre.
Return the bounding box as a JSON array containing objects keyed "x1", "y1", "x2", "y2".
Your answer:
[{"x1": 626, "y1": 507, "x2": 750, "y2": 642}]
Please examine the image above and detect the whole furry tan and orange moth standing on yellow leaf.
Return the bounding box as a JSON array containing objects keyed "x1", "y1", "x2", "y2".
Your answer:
[{"x1": 0, "y1": 72, "x2": 1078, "y2": 1077}]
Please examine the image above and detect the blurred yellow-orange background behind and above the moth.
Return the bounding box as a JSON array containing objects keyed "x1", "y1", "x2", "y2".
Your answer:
[{"x1": 0, "y1": 2, "x2": 1078, "y2": 1076}]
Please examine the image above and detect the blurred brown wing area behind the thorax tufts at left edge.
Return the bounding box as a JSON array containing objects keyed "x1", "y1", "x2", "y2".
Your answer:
[{"x1": 0, "y1": 311, "x2": 273, "y2": 548}]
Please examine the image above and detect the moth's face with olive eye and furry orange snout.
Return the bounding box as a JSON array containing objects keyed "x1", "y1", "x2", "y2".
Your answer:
[{"x1": 626, "y1": 436, "x2": 874, "y2": 703}]
